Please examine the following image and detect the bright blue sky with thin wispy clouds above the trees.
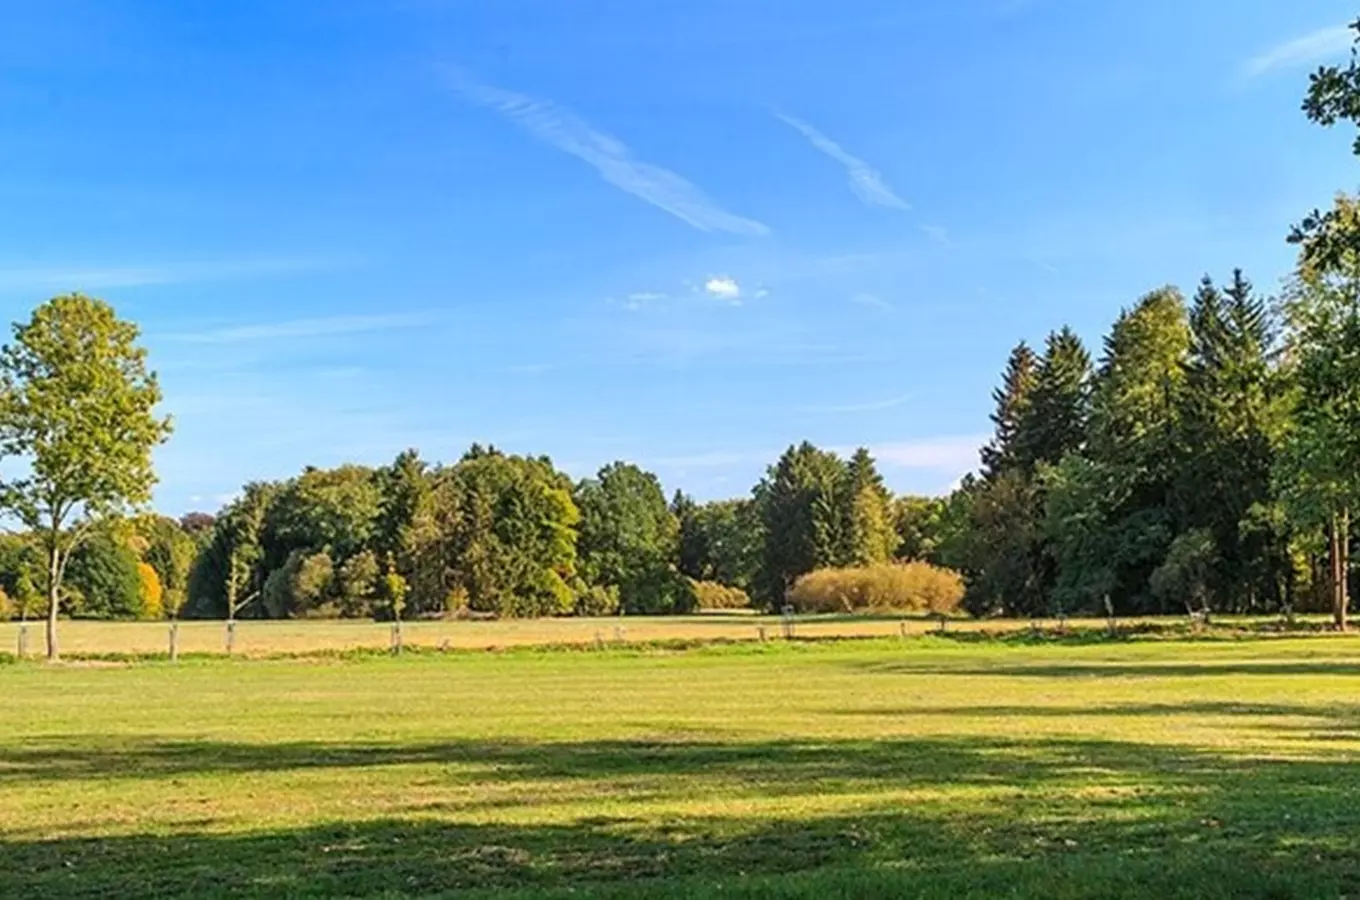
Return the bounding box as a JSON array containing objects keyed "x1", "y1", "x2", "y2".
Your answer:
[{"x1": 0, "y1": 0, "x2": 1360, "y2": 513}]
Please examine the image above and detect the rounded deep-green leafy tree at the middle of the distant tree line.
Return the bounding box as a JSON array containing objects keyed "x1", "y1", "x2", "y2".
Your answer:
[{"x1": 575, "y1": 462, "x2": 694, "y2": 615}]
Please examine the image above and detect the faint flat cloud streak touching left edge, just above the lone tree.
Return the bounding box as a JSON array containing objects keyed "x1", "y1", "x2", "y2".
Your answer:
[{"x1": 0, "y1": 258, "x2": 343, "y2": 291}]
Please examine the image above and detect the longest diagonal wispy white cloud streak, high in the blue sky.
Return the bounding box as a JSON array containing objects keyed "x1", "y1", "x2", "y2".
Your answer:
[{"x1": 445, "y1": 67, "x2": 770, "y2": 235}]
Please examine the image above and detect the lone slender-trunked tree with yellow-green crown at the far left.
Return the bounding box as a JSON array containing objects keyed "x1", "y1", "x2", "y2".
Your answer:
[{"x1": 0, "y1": 294, "x2": 170, "y2": 659}]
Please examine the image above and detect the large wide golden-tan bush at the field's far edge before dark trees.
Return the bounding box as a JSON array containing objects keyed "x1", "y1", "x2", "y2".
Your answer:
[{"x1": 789, "y1": 563, "x2": 963, "y2": 615}]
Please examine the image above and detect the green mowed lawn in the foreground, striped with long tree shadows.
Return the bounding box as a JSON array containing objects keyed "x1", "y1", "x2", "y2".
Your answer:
[{"x1": 0, "y1": 636, "x2": 1360, "y2": 899}]
